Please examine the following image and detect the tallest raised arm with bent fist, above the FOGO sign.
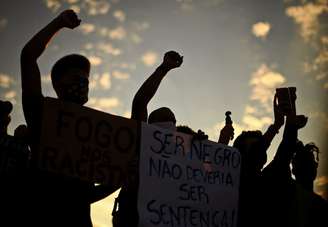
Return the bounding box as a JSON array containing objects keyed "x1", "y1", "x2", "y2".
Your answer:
[{"x1": 21, "y1": 10, "x2": 81, "y2": 97}]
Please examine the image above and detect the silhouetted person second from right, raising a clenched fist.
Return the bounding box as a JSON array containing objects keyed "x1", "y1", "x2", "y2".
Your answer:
[{"x1": 258, "y1": 87, "x2": 307, "y2": 227}]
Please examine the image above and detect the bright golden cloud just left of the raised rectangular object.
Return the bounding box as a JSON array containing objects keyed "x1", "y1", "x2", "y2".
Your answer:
[{"x1": 249, "y1": 64, "x2": 286, "y2": 106}]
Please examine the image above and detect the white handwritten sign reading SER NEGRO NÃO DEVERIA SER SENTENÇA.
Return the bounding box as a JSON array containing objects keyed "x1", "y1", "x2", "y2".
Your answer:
[{"x1": 138, "y1": 124, "x2": 241, "y2": 227}]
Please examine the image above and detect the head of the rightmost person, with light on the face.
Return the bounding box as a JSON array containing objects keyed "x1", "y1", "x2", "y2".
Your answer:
[{"x1": 292, "y1": 142, "x2": 319, "y2": 185}]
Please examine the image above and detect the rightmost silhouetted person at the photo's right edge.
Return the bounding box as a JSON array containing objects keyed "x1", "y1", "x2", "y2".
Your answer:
[{"x1": 290, "y1": 141, "x2": 328, "y2": 227}]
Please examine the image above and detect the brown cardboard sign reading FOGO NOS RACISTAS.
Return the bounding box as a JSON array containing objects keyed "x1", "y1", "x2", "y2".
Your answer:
[{"x1": 38, "y1": 98, "x2": 137, "y2": 188}]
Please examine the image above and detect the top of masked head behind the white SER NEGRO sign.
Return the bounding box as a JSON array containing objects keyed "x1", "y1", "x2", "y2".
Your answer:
[{"x1": 148, "y1": 107, "x2": 176, "y2": 129}]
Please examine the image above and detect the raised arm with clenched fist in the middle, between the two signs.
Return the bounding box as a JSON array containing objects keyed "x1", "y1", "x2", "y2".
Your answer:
[{"x1": 131, "y1": 51, "x2": 183, "y2": 122}]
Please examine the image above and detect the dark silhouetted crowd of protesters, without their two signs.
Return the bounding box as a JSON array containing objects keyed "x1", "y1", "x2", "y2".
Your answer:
[{"x1": 0, "y1": 10, "x2": 328, "y2": 227}]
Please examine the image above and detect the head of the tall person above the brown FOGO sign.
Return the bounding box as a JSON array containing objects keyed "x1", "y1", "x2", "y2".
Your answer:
[{"x1": 51, "y1": 54, "x2": 90, "y2": 105}]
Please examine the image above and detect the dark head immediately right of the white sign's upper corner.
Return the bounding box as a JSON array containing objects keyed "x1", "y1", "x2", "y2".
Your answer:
[{"x1": 233, "y1": 131, "x2": 267, "y2": 171}]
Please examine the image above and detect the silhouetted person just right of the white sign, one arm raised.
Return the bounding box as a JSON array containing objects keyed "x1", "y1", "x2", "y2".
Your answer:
[{"x1": 233, "y1": 93, "x2": 284, "y2": 226}]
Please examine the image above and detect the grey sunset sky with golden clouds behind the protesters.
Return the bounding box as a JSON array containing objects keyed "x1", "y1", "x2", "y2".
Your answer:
[{"x1": 0, "y1": 0, "x2": 328, "y2": 227}]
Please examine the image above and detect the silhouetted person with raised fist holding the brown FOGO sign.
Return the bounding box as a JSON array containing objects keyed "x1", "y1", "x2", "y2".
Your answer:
[{"x1": 21, "y1": 10, "x2": 111, "y2": 227}]
